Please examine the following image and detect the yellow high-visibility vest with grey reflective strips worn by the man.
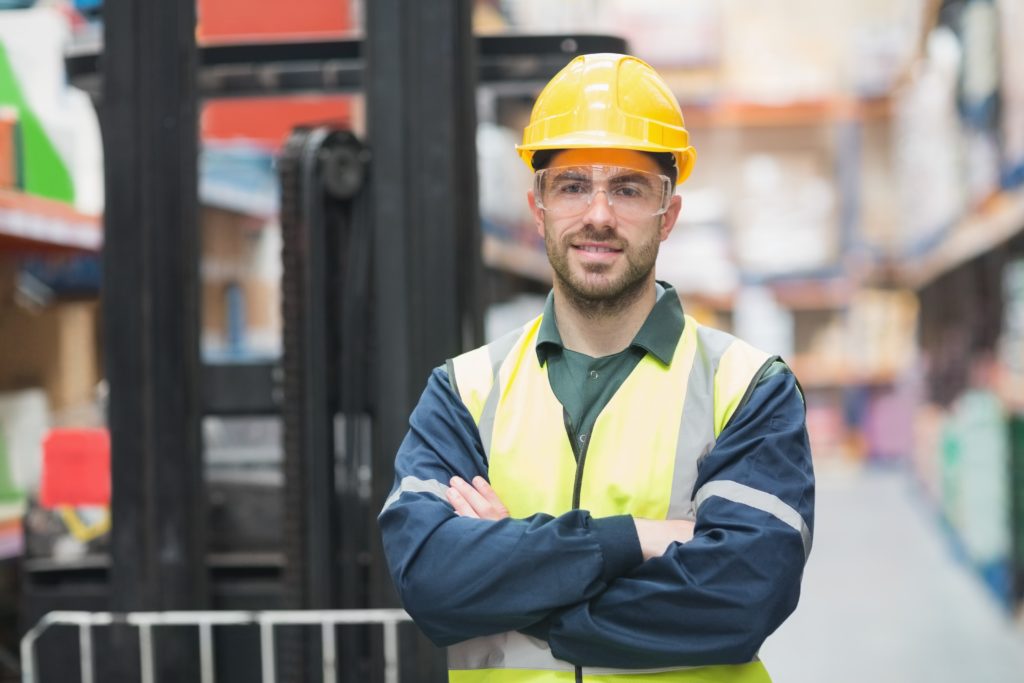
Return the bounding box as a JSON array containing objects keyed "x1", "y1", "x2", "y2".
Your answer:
[{"x1": 449, "y1": 315, "x2": 774, "y2": 683}]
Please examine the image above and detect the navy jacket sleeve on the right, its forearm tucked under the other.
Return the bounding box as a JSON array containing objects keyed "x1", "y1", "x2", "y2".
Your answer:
[{"x1": 522, "y1": 372, "x2": 814, "y2": 669}]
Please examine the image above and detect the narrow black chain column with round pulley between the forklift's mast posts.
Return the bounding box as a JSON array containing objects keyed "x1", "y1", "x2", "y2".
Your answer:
[{"x1": 279, "y1": 127, "x2": 370, "y2": 680}]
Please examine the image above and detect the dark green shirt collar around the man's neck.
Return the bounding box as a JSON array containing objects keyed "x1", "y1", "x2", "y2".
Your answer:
[{"x1": 536, "y1": 281, "x2": 684, "y2": 366}]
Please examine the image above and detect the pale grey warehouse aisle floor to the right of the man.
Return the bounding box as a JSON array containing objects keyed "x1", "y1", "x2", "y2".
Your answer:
[{"x1": 761, "y1": 467, "x2": 1024, "y2": 683}]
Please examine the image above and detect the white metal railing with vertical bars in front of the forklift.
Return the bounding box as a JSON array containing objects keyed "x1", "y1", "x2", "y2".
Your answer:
[{"x1": 22, "y1": 609, "x2": 411, "y2": 683}]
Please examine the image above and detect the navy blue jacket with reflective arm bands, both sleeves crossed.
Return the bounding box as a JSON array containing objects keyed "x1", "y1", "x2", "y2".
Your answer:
[{"x1": 379, "y1": 368, "x2": 814, "y2": 669}]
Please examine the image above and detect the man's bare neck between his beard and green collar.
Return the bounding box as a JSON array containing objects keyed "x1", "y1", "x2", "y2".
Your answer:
[{"x1": 554, "y1": 280, "x2": 657, "y2": 358}]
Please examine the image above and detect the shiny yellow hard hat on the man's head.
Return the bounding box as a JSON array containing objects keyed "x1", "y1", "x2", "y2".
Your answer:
[{"x1": 516, "y1": 53, "x2": 696, "y2": 184}]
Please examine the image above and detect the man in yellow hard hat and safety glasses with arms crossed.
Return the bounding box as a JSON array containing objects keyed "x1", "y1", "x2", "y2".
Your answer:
[{"x1": 380, "y1": 54, "x2": 814, "y2": 683}]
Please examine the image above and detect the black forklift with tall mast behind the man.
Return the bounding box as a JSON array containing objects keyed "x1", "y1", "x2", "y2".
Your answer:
[{"x1": 20, "y1": 0, "x2": 627, "y2": 683}]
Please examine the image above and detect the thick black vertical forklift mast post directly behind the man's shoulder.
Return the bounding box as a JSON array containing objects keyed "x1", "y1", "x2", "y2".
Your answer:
[{"x1": 366, "y1": 0, "x2": 482, "y2": 681}]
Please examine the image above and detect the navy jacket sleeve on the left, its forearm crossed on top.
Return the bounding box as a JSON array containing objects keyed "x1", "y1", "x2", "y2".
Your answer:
[{"x1": 378, "y1": 368, "x2": 643, "y2": 645}]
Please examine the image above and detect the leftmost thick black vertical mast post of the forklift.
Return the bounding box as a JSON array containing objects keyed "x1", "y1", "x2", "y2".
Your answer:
[{"x1": 100, "y1": 0, "x2": 208, "y2": 681}]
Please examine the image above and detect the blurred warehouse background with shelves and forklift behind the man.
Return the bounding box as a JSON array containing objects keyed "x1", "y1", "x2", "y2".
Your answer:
[{"x1": 0, "y1": 0, "x2": 1024, "y2": 682}]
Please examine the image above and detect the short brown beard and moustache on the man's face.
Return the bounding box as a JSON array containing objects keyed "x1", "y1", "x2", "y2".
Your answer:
[{"x1": 544, "y1": 226, "x2": 660, "y2": 317}]
